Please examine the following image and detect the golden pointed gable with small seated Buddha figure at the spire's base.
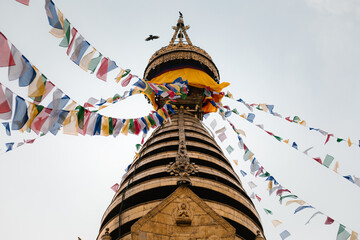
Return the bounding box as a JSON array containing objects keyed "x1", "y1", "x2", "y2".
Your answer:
[{"x1": 131, "y1": 186, "x2": 235, "y2": 240}]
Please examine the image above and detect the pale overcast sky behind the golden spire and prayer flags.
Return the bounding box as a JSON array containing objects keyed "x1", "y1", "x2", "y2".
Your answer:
[{"x1": 0, "y1": 0, "x2": 360, "y2": 240}]
